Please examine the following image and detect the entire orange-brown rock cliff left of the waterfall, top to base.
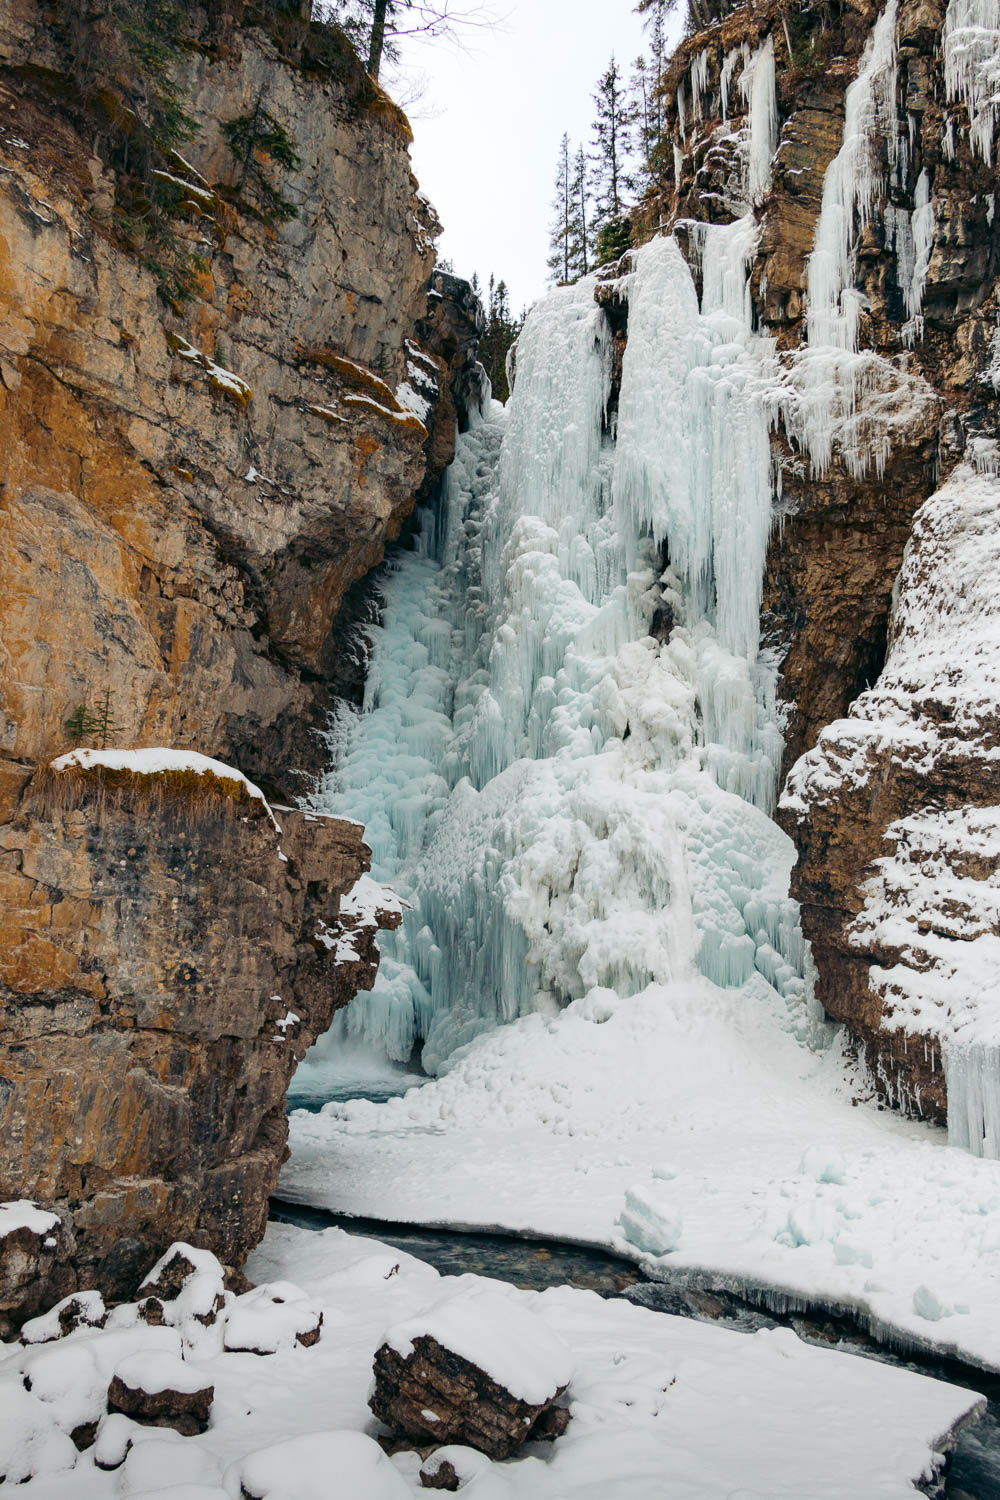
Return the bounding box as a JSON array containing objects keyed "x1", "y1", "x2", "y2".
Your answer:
[{"x1": 0, "y1": 0, "x2": 481, "y2": 1314}]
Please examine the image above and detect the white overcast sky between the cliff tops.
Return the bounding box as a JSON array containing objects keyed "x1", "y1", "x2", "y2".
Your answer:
[{"x1": 395, "y1": 0, "x2": 653, "y2": 311}]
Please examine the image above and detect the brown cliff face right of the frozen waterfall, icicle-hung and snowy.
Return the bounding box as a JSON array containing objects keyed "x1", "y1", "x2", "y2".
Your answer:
[{"x1": 645, "y1": 0, "x2": 1000, "y2": 1128}]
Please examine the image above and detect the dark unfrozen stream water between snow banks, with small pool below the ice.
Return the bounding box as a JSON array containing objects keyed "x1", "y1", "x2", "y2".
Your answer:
[{"x1": 271, "y1": 1079, "x2": 1000, "y2": 1500}]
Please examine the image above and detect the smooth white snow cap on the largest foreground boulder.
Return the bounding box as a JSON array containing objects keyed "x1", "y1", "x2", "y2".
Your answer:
[{"x1": 385, "y1": 1290, "x2": 573, "y2": 1406}]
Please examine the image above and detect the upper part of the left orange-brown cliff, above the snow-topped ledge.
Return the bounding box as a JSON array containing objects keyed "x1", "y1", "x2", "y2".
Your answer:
[{"x1": 0, "y1": 0, "x2": 475, "y2": 794}]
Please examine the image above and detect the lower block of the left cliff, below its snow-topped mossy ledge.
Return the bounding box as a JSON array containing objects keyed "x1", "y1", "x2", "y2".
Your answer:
[{"x1": 0, "y1": 770, "x2": 399, "y2": 1328}]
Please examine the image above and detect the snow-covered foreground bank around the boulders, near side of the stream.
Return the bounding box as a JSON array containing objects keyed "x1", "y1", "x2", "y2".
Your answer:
[{"x1": 0, "y1": 1226, "x2": 981, "y2": 1500}]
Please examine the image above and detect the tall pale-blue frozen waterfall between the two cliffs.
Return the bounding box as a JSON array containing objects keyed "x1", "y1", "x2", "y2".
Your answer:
[{"x1": 290, "y1": 218, "x2": 810, "y2": 1076}]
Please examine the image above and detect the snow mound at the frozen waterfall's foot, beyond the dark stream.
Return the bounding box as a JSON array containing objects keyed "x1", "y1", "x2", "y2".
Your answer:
[{"x1": 280, "y1": 981, "x2": 1000, "y2": 1370}]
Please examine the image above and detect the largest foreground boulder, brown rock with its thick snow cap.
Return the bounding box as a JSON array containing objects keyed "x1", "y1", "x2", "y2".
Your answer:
[{"x1": 369, "y1": 1290, "x2": 573, "y2": 1460}]
